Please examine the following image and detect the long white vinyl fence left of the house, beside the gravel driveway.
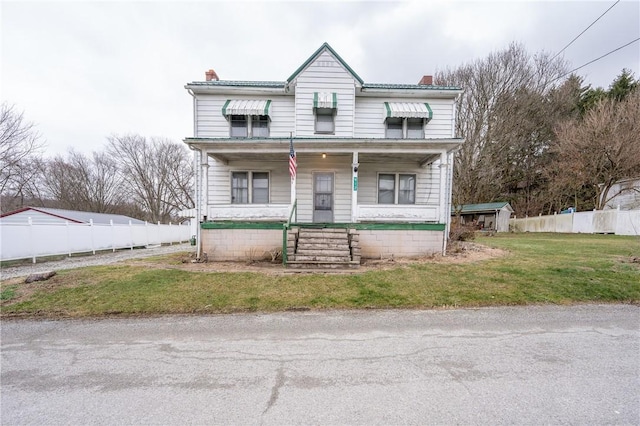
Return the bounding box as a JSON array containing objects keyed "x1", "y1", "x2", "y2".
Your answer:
[{"x1": 0, "y1": 223, "x2": 191, "y2": 263}]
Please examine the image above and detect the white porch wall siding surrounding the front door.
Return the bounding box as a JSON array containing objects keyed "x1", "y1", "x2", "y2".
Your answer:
[{"x1": 296, "y1": 155, "x2": 351, "y2": 222}]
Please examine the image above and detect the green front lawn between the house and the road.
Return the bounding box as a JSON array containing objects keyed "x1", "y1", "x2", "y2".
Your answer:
[{"x1": 2, "y1": 234, "x2": 640, "y2": 317}]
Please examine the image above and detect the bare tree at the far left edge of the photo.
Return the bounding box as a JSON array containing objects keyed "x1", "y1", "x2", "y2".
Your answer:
[{"x1": 0, "y1": 103, "x2": 44, "y2": 206}]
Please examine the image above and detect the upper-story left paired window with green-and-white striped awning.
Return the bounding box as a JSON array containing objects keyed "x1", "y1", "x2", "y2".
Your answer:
[{"x1": 222, "y1": 99, "x2": 271, "y2": 138}]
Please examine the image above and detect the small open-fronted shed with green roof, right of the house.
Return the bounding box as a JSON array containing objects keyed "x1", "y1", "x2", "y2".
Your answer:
[{"x1": 452, "y1": 201, "x2": 513, "y2": 232}]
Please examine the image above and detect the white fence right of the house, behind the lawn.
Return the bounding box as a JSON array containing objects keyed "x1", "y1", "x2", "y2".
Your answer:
[{"x1": 509, "y1": 210, "x2": 640, "y2": 235}]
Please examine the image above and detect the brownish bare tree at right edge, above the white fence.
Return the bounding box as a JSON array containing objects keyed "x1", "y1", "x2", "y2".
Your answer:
[{"x1": 553, "y1": 90, "x2": 640, "y2": 209}]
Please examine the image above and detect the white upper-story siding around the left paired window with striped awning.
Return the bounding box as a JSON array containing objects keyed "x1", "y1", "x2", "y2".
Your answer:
[{"x1": 194, "y1": 95, "x2": 294, "y2": 138}]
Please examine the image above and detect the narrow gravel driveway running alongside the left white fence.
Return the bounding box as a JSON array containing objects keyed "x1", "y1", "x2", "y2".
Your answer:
[{"x1": 0, "y1": 243, "x2": 195, "y2": 280}]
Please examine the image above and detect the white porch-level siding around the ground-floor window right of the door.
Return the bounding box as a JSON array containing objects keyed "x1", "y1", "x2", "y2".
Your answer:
[{"x1": 358, "y1": 163, "x2": 440, "y2": 206}]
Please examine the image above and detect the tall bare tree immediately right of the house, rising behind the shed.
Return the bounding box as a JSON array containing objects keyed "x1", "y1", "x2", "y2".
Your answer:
[{"x1": 435, "y1": 44, "x2": 566, "y2": 213}]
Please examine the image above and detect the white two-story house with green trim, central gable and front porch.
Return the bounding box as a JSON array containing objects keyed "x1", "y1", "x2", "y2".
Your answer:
[{"x1": 185, "y1": 43, "x2": 463, "y2": 262}]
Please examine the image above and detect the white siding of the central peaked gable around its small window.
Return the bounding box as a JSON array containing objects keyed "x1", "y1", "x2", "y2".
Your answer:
[{"x1": 295, "y1": 52, "x2": 355, "y2": 137}]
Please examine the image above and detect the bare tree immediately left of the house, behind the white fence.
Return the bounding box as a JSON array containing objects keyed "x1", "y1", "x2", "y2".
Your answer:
[{"x1": 107, "y1": 135, "x2": 194, "y2": 222}]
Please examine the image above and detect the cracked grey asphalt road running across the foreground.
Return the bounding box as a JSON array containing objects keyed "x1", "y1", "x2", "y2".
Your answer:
[{"x1": 0, "y1": 305, "x2": 640, "y2": 425}]
